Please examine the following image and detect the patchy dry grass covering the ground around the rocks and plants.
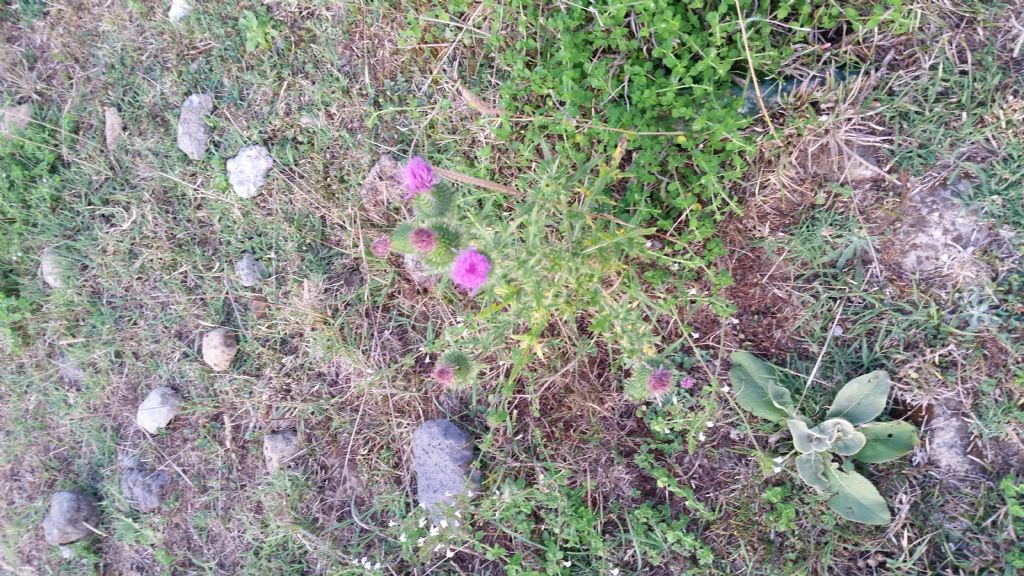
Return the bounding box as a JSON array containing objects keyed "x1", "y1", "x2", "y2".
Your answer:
[{"x1": 0, "y1": 2, "x2": 1024, "y2": 574}]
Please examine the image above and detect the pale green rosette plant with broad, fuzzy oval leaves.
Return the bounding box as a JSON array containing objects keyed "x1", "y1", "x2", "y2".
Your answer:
[{"x1": 729, "y1": 351, "x2": 919, "y2": 525}]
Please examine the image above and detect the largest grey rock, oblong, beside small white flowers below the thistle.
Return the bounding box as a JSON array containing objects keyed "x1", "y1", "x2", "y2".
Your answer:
[{"x1": 413, "y1": 420, "x2": 479, "y2": 512}]
